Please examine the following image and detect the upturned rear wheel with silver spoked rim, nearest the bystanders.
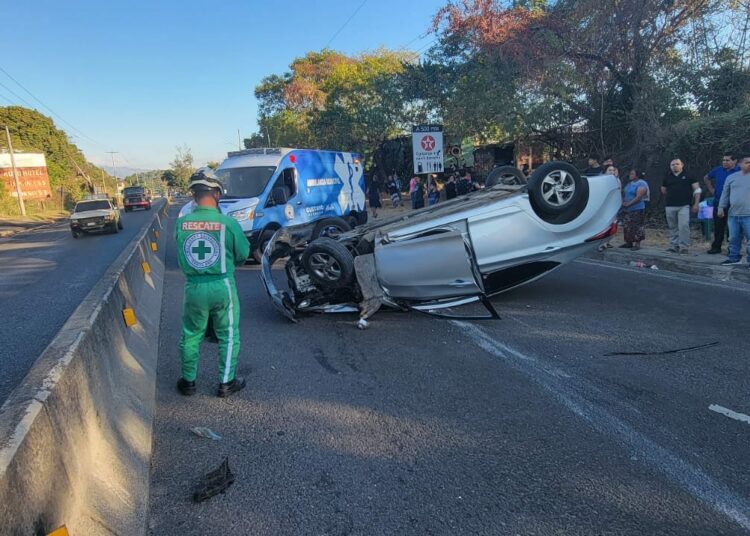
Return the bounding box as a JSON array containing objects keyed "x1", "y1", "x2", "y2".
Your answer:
[{"x1": 527, "y1": 162, "x2": 589, "y2": 224}]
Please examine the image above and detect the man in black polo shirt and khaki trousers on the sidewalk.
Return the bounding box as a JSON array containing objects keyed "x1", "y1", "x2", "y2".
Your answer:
[{"x1": 661, "y1": 158, "x2": 701, "y2": 255}]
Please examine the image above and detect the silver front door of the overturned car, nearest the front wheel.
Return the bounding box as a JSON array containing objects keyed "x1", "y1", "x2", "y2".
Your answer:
[{"x1": 375, "y1": 228, "x2": 482, "y2": 301}]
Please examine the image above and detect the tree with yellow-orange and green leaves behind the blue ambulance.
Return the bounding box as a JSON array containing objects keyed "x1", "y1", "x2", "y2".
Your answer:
[{"x1": 245, "y1": 50, "x2": 426, "y2": 168}]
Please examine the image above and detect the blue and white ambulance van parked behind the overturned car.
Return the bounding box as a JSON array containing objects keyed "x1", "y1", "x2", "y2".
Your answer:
[{"x1": 180, "y1": 148, "x2": 367, "y2": 261}]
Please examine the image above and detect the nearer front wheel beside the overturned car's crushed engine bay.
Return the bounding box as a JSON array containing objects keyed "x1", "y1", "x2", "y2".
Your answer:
[{"x1": 300, "y1": 237, "x2": 354, "y2": 289}]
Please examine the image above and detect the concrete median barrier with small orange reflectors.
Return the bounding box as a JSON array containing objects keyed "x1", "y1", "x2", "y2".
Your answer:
[{"x1": 0, "y1": 200, "x2": 168, "y2": 535}]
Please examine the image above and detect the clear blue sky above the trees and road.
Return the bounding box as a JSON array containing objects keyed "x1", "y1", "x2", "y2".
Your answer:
[{"x1": 0, "y1": 0, "x2": 446, "y2": 169}]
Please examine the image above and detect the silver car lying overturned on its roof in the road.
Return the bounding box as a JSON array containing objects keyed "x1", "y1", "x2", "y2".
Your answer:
[{"x1": 261, "y1": 162, "x2": 621, "y2": 320}]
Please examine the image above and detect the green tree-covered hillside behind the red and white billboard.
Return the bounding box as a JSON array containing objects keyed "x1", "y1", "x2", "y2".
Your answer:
[{"x1": 0, "y1": 106, "x2": 115, "y2": 201}]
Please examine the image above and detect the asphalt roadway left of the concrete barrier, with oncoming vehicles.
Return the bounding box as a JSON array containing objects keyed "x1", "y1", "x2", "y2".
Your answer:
[{"x1": 0, "y1": 204, "x2": 161, "y2": 404}]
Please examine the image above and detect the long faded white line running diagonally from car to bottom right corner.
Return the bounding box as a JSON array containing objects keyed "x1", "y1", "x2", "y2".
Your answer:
[{"x1": 451, "y1": 320, "x2": 750, "y2": 531}]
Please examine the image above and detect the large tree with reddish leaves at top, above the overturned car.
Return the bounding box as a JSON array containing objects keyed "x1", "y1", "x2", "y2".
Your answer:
[{"x1": 433, "y1": 0, "x2": 740, "y2": 168}]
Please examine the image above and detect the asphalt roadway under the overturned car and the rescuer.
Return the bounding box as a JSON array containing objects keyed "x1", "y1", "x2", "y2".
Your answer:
[{"x1": 149, "y1": 206, "x2": 750, "y2": 535}]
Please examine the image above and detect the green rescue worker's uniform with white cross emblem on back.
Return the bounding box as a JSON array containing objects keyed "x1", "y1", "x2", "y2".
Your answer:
[{"x1": 176, "y1": 206, "x2": 250, "y2": 383}]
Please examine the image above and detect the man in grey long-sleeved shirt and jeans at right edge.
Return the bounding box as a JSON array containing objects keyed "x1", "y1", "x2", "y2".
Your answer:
[{"x1": 717, "y1": 155, "x2": 750, "y2": 266}]
